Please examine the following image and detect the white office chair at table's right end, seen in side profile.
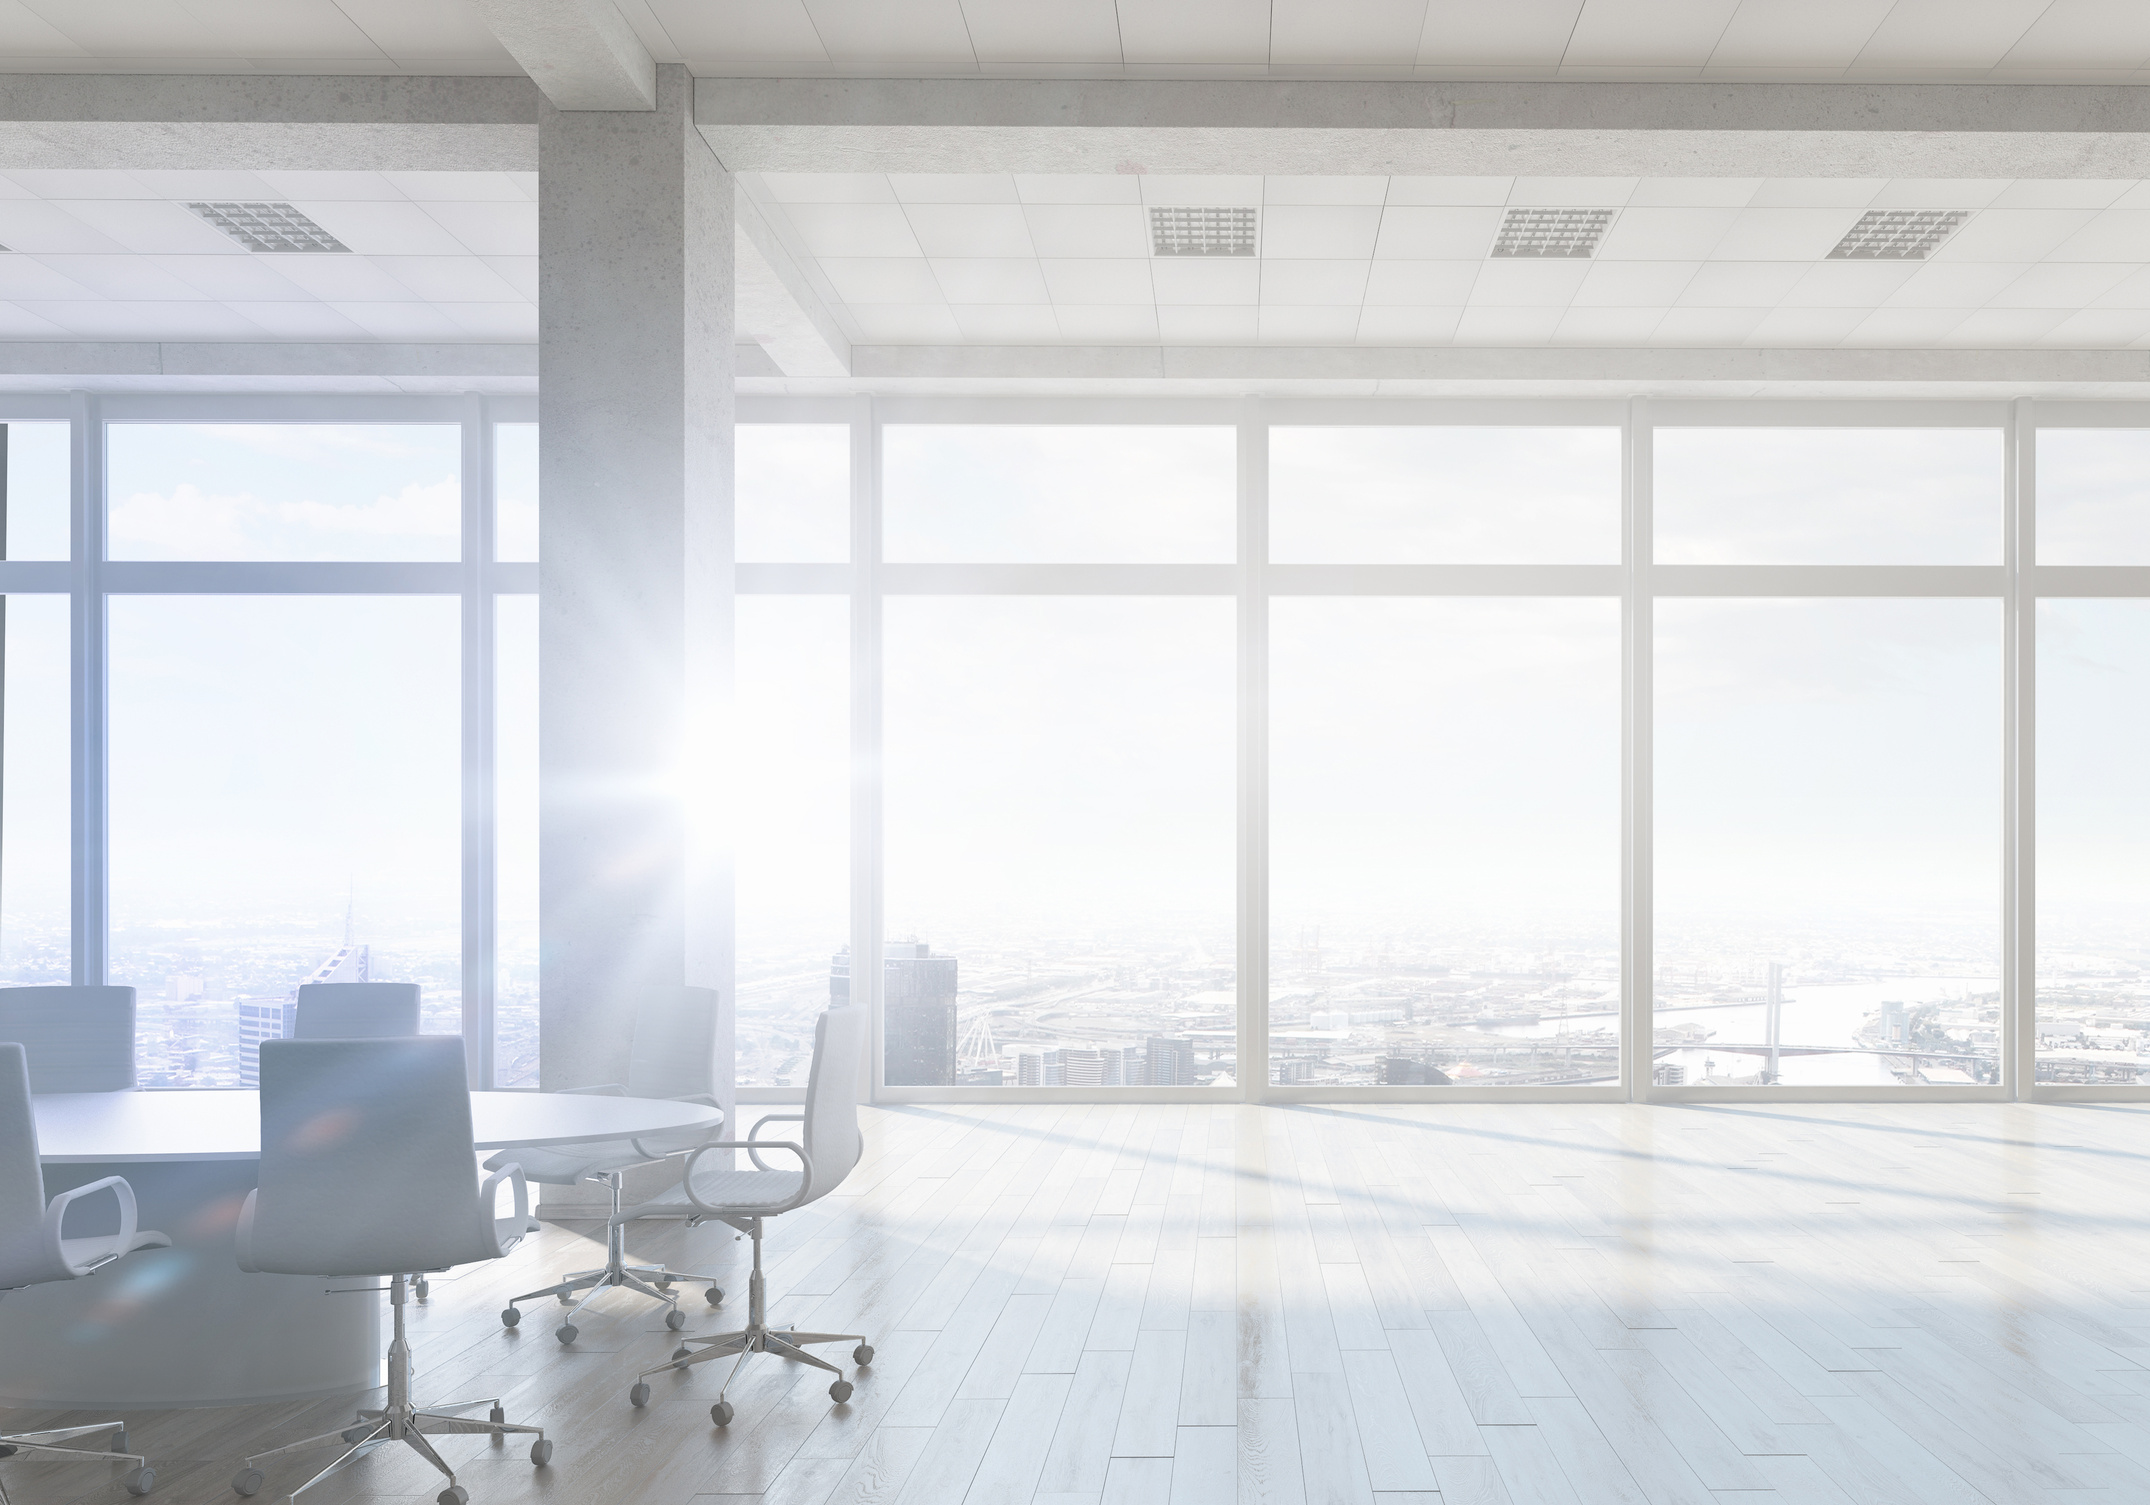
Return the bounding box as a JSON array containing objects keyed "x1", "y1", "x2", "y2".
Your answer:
[{"x1": 621, "y1": 1008, "x2": 873, "y2": 1425}]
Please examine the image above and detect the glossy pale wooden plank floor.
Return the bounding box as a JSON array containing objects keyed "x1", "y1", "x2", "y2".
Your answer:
[{"x1": 12, "y1": 1105, "x2": 2150, "y2": 1505}]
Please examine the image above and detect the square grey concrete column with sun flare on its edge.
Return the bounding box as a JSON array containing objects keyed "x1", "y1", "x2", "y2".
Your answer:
[{"x1": 538, "y1": 65, "x2": 733, "y2": 1202}]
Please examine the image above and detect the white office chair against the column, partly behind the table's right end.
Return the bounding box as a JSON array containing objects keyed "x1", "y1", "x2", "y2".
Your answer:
[{"x1": 486, "y1": 987, "x2": 725, "y2": 1344}]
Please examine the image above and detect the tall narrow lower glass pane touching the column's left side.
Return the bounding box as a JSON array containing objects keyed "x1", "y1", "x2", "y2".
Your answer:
[{"x1": 492, "y1": 596, "x2": 538, "y2": 1088}]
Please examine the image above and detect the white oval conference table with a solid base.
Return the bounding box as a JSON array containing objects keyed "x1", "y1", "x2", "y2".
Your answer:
[{"x1": 0, "y1": 1090, "x2": 725, "y2": 1406}]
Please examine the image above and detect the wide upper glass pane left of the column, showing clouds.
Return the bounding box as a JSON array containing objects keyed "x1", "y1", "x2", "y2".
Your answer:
[{"x1": 105, "y1": 424, "x2": 462, "y2": 561}]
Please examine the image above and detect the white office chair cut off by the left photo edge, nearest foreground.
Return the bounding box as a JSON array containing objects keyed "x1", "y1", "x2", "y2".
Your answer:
[{"x1": 0, "y1": 1040, "x2": 172, "y2": 1505}]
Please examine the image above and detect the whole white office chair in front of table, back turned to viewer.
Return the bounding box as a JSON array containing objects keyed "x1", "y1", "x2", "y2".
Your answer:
[{"x1": 232, "y1": 1034, "x2": 553, "y2": 1505}]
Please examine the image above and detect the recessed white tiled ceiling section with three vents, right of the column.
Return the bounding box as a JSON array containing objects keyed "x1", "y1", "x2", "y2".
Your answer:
[{"x1": 748, "y1": 174, "x2": 2150, "y2": 348}]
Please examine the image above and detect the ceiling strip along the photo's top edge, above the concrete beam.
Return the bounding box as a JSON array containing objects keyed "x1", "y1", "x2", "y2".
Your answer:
[{"x1": 0, "y1": 0, "x2": 2150, "y2": 82}]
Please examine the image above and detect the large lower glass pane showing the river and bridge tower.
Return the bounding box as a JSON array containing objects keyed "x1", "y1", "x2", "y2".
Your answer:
[{"x1": 1653, "y1": 600, "x2": 2002, "y2": 1086}]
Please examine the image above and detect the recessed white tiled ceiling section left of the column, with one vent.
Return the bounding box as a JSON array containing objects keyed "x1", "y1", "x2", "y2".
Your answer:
[{"x1": 0, "y1": 170, "x2": 538, "y2": 344}]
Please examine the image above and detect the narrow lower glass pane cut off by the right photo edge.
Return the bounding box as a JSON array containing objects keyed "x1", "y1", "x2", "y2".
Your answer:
[{"x1": 2038, "y1": 597, "x2": 2150, "y2": 1086}]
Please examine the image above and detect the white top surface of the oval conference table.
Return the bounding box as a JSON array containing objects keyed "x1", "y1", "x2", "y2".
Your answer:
[{"x1": 32, "y1": 1090, "x2": 725, "y2": 1165}]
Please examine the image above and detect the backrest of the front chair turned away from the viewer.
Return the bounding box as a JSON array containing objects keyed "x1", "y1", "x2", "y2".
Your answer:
[{"x1": 241, "y1": 1034, "x2": 499, "y2": 1275}]
